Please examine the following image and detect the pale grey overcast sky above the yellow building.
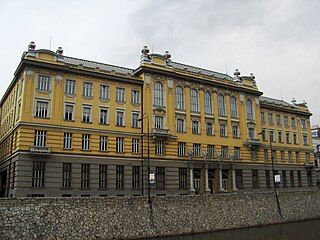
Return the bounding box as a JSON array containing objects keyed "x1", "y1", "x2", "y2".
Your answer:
[{"x1": 0, "y1": 0, "x2": 320, "y2": 125}]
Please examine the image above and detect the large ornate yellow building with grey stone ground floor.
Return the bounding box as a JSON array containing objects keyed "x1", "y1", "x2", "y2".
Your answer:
[{"x1": 0, "y1": 42, "x2": 316, "y2": 197}]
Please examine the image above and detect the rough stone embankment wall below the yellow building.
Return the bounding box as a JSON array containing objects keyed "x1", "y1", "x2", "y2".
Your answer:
[{"x1": 0, "y1": 191, "x2": 320, "y2": 239}]
